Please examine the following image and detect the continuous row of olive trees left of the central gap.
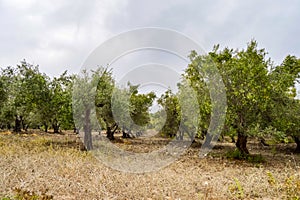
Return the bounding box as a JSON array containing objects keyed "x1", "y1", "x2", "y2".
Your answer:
[{"x1": 0, "y1": 61, "x2": 155, "y2": 143}]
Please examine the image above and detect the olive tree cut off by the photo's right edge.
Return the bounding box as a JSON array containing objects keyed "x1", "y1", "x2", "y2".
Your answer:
[{"x1": 265, "y1": 55, "x2": 300, "y2": 153}]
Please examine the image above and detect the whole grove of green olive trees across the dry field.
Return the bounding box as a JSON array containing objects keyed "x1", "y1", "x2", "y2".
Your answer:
[{"x1": 0, "y1": 41, "x2": 300, "y2": 154}]
